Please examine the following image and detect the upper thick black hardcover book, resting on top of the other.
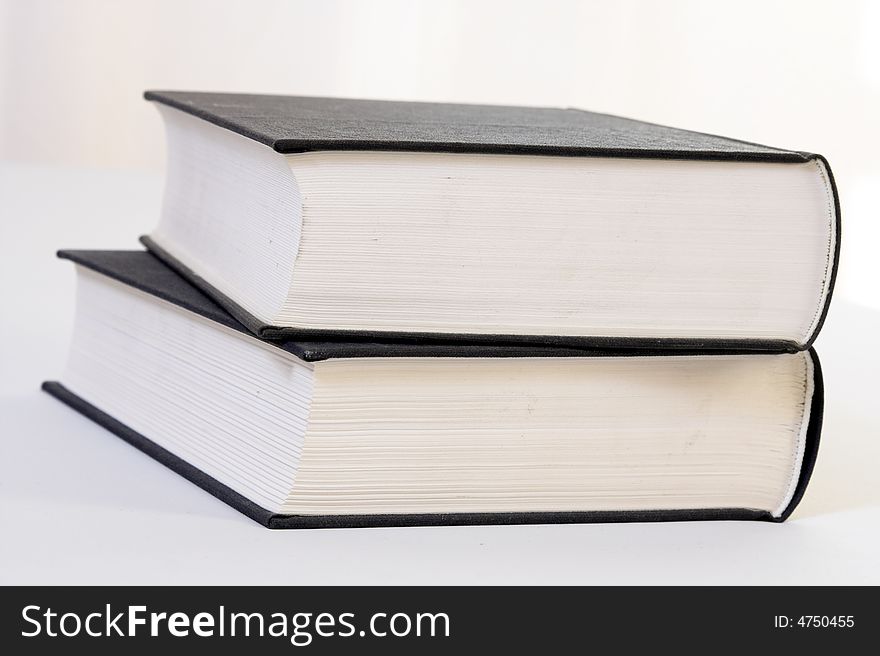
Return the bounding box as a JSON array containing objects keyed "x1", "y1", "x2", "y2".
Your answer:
[{"x1": 145, "y1": 92, "x2": 840, "y2": 352}]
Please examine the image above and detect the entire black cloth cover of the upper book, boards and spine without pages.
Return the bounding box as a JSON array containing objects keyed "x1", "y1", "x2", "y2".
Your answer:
[{"x1": 141, "y1": 91, "x2": 840, "y2": 353}]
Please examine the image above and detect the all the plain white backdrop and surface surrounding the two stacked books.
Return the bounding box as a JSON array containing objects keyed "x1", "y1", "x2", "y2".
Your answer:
[{"x1": 0, "y1": 0, "x2": 880, "y2": 584}]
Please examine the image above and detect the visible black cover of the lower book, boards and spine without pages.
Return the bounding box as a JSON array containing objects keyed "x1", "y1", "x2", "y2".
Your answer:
[{"x1": 43, "y1": 251, "x2": 824, "y2": 528}]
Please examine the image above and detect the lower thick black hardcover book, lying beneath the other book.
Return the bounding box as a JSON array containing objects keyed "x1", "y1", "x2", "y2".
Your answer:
[{"x1": 43, "y1": 252, "x2": 822, "y2": 528}]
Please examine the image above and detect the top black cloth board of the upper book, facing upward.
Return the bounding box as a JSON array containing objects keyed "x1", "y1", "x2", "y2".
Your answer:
[{"x1": 144, "y1": 91, "x2": 832, "y2": 162}]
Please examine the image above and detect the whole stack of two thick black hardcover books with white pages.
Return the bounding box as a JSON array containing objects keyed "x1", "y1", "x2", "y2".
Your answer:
[{"x1": 44, "y1": 92, "x2": 840, "y2": 528}]
